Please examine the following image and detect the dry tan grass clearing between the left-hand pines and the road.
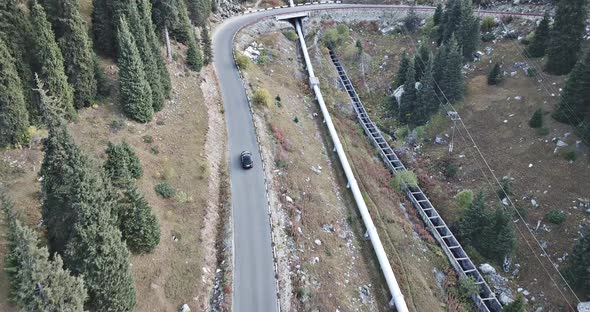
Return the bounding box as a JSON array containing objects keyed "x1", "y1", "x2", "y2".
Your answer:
[{"x1": 0, "y1": 58, "x2": 209, "y2": 311}]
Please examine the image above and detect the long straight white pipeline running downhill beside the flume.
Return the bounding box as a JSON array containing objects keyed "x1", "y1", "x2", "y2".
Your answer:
[{"x1": 295, "y1": 20, "x2": 408, "y2": 312}]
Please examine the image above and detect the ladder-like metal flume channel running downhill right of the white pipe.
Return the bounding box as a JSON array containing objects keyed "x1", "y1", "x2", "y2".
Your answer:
[{"x1": 330, "y1": 49, "x2": 502, "y2": 312}]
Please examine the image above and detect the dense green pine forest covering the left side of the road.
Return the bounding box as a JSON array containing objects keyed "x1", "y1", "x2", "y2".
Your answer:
[{"x1": 0, "y1": 0, "x2": 213, "y2": 311}]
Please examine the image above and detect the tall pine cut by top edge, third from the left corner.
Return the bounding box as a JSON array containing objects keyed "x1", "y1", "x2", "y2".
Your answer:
[{"x1": 55, "y1": 0, "x2": 97, "y2": 108}]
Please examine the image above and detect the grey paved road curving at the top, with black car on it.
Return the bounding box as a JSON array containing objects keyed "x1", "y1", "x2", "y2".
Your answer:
[{"x1": 213, "y1": 4, "x2": 539, "y2": 312}]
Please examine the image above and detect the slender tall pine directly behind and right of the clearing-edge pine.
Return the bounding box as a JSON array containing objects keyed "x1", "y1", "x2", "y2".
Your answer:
[{"x1": 128, "y1": 1, "x2": 164, "y2": 111}]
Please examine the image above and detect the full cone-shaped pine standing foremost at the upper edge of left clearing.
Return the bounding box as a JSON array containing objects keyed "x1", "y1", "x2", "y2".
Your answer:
[{"x1": 118, "y1": 19, "x2": 154, "y2": 122}]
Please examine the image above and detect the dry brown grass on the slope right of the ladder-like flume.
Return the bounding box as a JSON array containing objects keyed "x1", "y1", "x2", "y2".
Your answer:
[{"x1": 336, "y1": 20, "x2": 590, "y2": 309}]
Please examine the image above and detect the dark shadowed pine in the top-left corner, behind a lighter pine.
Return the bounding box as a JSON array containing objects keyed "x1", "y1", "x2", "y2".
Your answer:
[{"x1": 0, "y1": 0, "x2": 39, "y2": 122}]
